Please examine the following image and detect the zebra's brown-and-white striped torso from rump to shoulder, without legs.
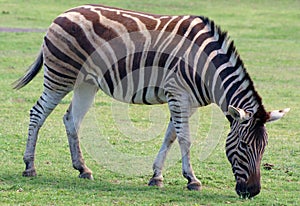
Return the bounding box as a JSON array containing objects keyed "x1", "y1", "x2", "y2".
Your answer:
[{"x1": 43, "y1": 5, "x2": 211, "y2": 104}]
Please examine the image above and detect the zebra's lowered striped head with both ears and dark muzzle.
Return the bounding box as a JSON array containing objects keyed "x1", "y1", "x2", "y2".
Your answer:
[{"x1": 226, "y1": 106, "x2": 289, "y2": 198}]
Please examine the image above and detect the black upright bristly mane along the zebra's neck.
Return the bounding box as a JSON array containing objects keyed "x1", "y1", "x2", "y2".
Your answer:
[{"x1": 200, "y1": 16, "x2": 269, "y2": 120}]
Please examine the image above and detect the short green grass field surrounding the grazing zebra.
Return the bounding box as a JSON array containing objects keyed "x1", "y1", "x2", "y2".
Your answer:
[{"x1": 0, "y1": 0, "x2": 300, "y2": 205}]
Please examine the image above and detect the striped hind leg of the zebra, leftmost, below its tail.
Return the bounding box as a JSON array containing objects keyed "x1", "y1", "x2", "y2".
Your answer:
[{"x1": 23, "y1": 89, "x2": 68, "y2": 177}]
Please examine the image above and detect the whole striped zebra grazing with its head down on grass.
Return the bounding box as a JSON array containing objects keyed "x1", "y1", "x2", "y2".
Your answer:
[{"x1": 14, "y1": 5, "x2": 289, "y2": 197}]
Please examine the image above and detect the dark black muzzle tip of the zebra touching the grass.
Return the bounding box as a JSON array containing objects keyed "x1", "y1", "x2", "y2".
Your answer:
[{"x1": 235, "y1": 181, "x2": 261, "y2": 198}]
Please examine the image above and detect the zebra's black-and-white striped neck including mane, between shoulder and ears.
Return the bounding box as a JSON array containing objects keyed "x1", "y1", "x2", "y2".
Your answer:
[{"x1": 192, "y1": 17, "x2": 265, "y2": 119}]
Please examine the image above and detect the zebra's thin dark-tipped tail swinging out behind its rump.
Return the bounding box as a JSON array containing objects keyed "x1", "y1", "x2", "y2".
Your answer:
[{"x1": 13, "y1": 50, "x2": 43, "y2": 89}]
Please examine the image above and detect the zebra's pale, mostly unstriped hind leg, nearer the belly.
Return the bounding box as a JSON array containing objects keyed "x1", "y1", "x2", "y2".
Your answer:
[{"x1": 63, "y1": 83, "x2": 98, "y2": 179}]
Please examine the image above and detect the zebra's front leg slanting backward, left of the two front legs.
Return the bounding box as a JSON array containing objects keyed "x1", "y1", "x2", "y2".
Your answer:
[{"x1": 148, "y1": 121, "x2": 176, "y2": 187}]
